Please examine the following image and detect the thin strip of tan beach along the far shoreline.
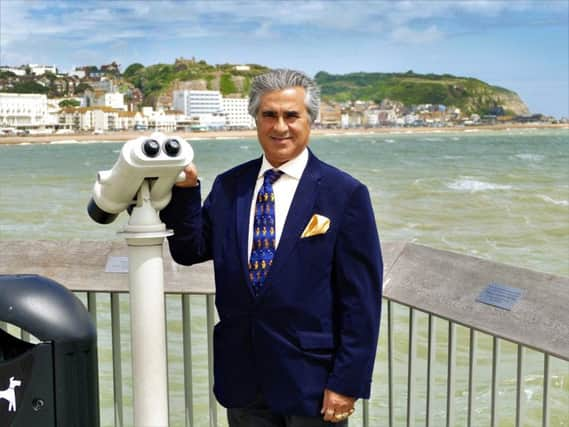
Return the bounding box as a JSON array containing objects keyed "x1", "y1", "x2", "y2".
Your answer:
[{"x1": 0, "y1": 123, "x2": 569, "y2": 144}]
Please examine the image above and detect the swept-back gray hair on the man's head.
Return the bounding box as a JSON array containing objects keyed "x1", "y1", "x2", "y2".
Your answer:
[{"x1": 249, "y1": 69, "x2": 320, "y2": 123}]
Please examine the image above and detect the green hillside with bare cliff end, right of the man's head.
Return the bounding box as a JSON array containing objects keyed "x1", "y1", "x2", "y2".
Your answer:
[{"x1": 315, "y1": 71, "x2": 529, "y2": 115}]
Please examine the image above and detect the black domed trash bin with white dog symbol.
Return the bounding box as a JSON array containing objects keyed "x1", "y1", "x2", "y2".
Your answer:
[{"x1": 0, "y1": 274, "x2": 99, "y2": 427}]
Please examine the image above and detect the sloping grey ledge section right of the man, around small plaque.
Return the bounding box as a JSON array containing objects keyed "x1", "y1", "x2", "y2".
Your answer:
[{"x1": 384, "y1": 244, "x2": 569, "y2": 360}]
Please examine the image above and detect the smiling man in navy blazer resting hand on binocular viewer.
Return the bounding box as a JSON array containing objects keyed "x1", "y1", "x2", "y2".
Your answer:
[{"x1": 161, "y1": 70, "x2": 382, "y2": 427}]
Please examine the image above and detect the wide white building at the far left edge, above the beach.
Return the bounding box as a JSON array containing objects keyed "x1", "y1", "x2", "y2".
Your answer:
[{"x1": 0, "y1": 93, "x2": 48, "y2": 128}]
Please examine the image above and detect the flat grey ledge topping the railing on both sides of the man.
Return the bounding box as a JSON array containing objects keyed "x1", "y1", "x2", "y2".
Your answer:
[{"x1": 0, "y1": 240, "x2": 569, "y2": 360}]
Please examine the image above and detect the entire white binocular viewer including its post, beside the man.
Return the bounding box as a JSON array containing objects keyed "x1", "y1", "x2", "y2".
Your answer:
[{"x1": 87, "y1": 133, "x2": 194, "y2": 427}]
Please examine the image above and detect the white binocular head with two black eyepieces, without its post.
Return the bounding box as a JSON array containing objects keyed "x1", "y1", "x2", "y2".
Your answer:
[{"x1": 87, "y1": 133, "x2": 194, "y2": 224}]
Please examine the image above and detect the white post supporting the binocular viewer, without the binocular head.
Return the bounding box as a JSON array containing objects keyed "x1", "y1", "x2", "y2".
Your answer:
[{"x1": 120, "y1": 180, "x2": 173, "y2": 427}]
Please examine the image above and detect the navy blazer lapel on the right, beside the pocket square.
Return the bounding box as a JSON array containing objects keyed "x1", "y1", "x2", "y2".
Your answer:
[{"x1": 267, "y1": 151, "x2": 320, "y2": 287}]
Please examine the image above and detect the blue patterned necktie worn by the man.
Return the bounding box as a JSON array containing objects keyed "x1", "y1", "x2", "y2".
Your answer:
[{"x1": 249, "y1": 169, "x2": 283, "y2": 296}]
